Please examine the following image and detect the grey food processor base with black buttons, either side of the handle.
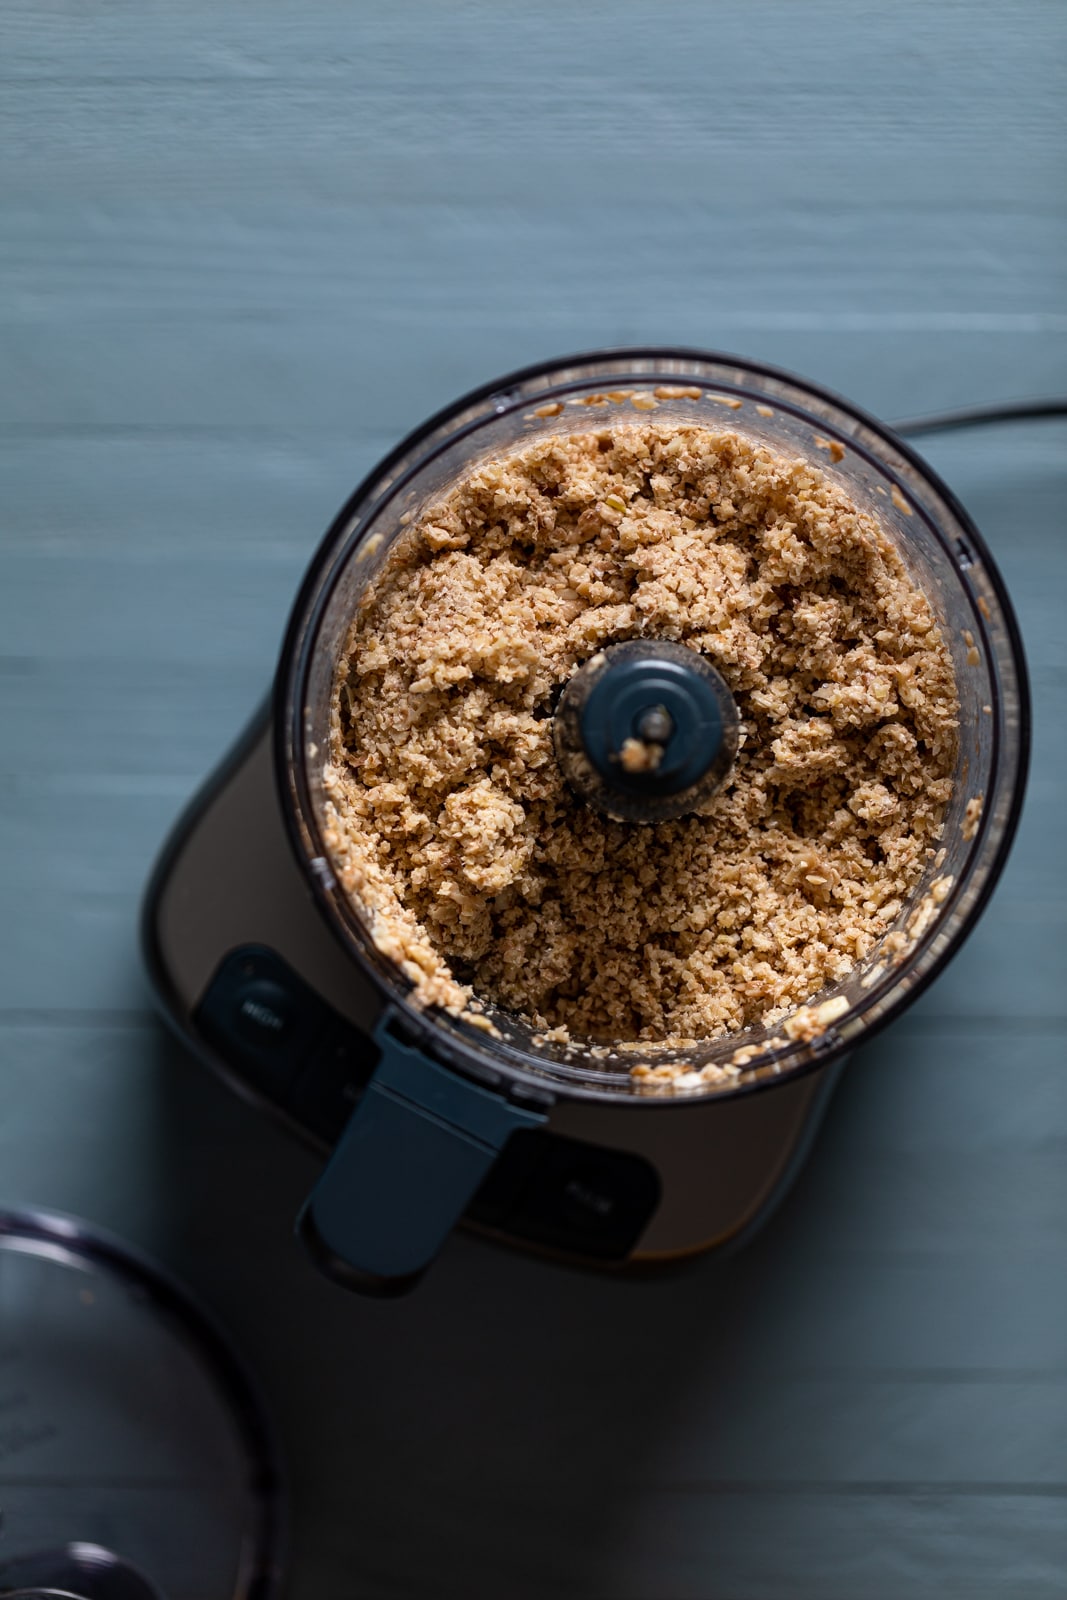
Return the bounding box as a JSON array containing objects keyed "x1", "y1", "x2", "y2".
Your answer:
[{"x1": 142, "y1": 707, "x2": 843, "y2": 1267}]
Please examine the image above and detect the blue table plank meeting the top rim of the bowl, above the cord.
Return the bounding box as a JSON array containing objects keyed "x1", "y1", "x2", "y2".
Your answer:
[{"x1": 0, "y1": 320, "x2": 1067, "y2": 438}]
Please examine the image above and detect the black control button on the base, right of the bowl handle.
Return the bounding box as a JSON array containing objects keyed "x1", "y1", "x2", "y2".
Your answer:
[{"x1": 470, "y1": 1131, "x2": 661, "y2": 1261}]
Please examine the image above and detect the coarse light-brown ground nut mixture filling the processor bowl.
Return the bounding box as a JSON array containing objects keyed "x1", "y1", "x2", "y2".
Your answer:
[{"x1": 326, "y1": 419, "x2": 958, "y2": 1045}]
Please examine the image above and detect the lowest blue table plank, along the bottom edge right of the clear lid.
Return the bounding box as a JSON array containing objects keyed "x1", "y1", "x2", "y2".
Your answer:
[{"x1": 299, "y1": 1483, "x2": 1064, "y2": 1600}]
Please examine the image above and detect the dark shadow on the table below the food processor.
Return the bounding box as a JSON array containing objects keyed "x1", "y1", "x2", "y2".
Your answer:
[{"x1": 146, "y1": 1029, "x2": 857, "y2": 1600}]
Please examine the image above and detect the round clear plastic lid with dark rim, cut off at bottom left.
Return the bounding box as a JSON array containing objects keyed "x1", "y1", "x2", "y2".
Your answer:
[{"x1": 0, "y1": 1210, "x2": 286, "y2": 1600}]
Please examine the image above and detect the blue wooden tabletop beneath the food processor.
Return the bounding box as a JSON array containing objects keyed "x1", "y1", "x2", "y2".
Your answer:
[{"x1": 0, "y1": 0, "x2": 1067, "y2": 1600}]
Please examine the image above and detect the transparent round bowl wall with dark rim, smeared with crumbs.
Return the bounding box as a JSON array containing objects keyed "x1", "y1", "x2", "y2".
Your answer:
[{"x1": 277, "y1": 350, "x2": 1029, "y2": 1099}]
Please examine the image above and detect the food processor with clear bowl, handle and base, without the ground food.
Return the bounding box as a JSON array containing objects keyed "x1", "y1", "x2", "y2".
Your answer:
[{"x1": 144, "y1": 349, "x2": 1029, "y2": 1293}]
